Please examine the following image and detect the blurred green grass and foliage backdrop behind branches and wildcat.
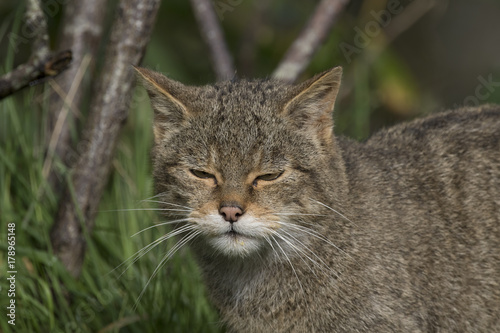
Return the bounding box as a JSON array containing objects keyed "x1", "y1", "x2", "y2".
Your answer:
[{"x1": 0, "y1": 0, "x2": 500, "y2": 332}]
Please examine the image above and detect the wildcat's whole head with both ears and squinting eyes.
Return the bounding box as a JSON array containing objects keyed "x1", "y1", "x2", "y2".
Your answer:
[{"x1": 136, "y1": 67, "x2": 343, "y2": 256}]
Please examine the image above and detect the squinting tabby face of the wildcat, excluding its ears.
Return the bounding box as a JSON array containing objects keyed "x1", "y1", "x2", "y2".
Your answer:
[{"x1": 155, "y1": 102, "x2": 312, "y2": 255}]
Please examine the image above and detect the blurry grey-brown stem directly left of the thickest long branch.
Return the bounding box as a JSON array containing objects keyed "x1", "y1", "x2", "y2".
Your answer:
[{"x1": 44, "y1": 0, "x2": 108, "y2": 188}]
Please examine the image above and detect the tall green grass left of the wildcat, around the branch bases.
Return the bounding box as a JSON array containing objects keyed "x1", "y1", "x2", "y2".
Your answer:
[{"x1": 0, "y1": 81, "x2": 221, "y2": 332}]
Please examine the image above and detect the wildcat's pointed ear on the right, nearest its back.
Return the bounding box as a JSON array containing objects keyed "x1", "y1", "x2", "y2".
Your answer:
[{"x1": 284, "y1": 67, "x2": 342, "y2": 142}]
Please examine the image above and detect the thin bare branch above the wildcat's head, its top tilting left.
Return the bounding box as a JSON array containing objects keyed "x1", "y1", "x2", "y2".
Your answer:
[{"x1": 191, "y1": 0, "x2": 235, "y2": 81}]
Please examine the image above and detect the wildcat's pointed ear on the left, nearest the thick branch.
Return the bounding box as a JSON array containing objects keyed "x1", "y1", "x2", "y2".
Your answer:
[{"x1": 134, "y1": 66, "x2": 189, "y2": 144}]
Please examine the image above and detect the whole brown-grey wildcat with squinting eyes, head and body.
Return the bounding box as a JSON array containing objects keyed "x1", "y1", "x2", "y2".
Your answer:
[{"x1": 136, "y1": 67, "x2": 500, "y2": 332}]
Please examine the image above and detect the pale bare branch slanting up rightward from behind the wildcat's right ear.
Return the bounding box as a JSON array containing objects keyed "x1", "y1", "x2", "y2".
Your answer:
[{"x1": 273, "y1": 0, "x2": 349, "y2": 82}]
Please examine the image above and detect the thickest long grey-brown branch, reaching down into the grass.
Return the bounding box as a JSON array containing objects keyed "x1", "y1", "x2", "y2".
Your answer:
[{"x1": 51, "y1": 0, "x2": 160, "y2": 276}]
